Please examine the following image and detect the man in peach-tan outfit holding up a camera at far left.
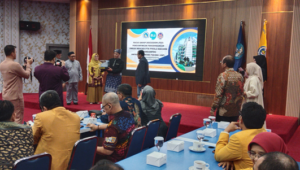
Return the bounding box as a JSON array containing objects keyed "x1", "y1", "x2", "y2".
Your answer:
[{"x1": 0, "y1": 45, "x2": 32, "y2": 124}]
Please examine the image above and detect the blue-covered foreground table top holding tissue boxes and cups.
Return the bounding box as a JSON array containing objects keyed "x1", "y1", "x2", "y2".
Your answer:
[{"x1": 117, "y1": 124, "x2": 239, "y2": 170}]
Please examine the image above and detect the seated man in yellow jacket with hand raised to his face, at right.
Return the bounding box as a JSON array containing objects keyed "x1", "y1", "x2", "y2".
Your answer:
[{"x1": 215, "y1": 102, "x2": 266, "y2": 170}]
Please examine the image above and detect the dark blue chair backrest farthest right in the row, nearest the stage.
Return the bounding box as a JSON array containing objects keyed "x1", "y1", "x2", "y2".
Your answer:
[{"x1": 165, "y1": 113, "x2": 181, "y2": 141}]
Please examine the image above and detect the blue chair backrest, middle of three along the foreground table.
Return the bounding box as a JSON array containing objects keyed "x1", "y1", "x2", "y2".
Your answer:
[{"x1": 143, "y1": 119, "x2": 160, "y2": 150}]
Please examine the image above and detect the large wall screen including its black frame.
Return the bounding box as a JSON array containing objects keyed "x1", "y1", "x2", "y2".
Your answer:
[{"x1": 121, "y1": 19, "x2": 206, "y2": 81}]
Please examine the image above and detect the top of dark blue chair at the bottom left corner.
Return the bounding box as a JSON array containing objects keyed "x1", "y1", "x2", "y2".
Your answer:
[{"x1": 13, "y1": 152, "x2": 52, "y2": 170}]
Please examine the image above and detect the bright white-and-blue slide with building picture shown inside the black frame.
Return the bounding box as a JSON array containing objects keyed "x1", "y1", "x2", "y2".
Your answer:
[{"x1": 126, "y1": 27, "x2": 198, "y2": 73}]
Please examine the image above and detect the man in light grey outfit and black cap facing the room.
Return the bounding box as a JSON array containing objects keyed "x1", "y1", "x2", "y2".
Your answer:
[{"x1": 66, "y1": 52, "x2": 82, "y2": 105}]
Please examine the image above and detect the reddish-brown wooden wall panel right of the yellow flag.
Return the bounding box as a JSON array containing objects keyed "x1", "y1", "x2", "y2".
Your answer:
[{"x1": 262, "y1": 13, "x2": 293, "y2": 115}]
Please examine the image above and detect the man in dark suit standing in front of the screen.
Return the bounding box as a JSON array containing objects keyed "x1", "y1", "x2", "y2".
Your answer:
[{"x1": 135, "y1": 50, "x2": 150, "y2": 97}]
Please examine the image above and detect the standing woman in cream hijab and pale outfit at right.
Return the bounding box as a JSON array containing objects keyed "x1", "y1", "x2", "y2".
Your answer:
[{"x1": 244, "y1": 63, "x2": 264, "y2": 107}]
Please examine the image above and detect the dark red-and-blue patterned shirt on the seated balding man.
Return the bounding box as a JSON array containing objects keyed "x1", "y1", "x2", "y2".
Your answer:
[{"x1": 103, "y1": 110, "x2": 135, "y2": 162}]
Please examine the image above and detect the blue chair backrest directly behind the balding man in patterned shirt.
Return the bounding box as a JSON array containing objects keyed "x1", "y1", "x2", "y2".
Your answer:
[{"x1": 126, "y1": 126, "x2": 146, "y2": 158}]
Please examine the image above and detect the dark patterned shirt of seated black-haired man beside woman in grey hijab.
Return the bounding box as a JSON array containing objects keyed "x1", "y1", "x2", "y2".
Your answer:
[{"x1": 120, "y1": 96, "x2": 148, "y2": 128}]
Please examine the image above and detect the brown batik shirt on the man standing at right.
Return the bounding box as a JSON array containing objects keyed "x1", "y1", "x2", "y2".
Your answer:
[{"x1": 211, "y1": 68, "x2": 244, "y2": 117}]
